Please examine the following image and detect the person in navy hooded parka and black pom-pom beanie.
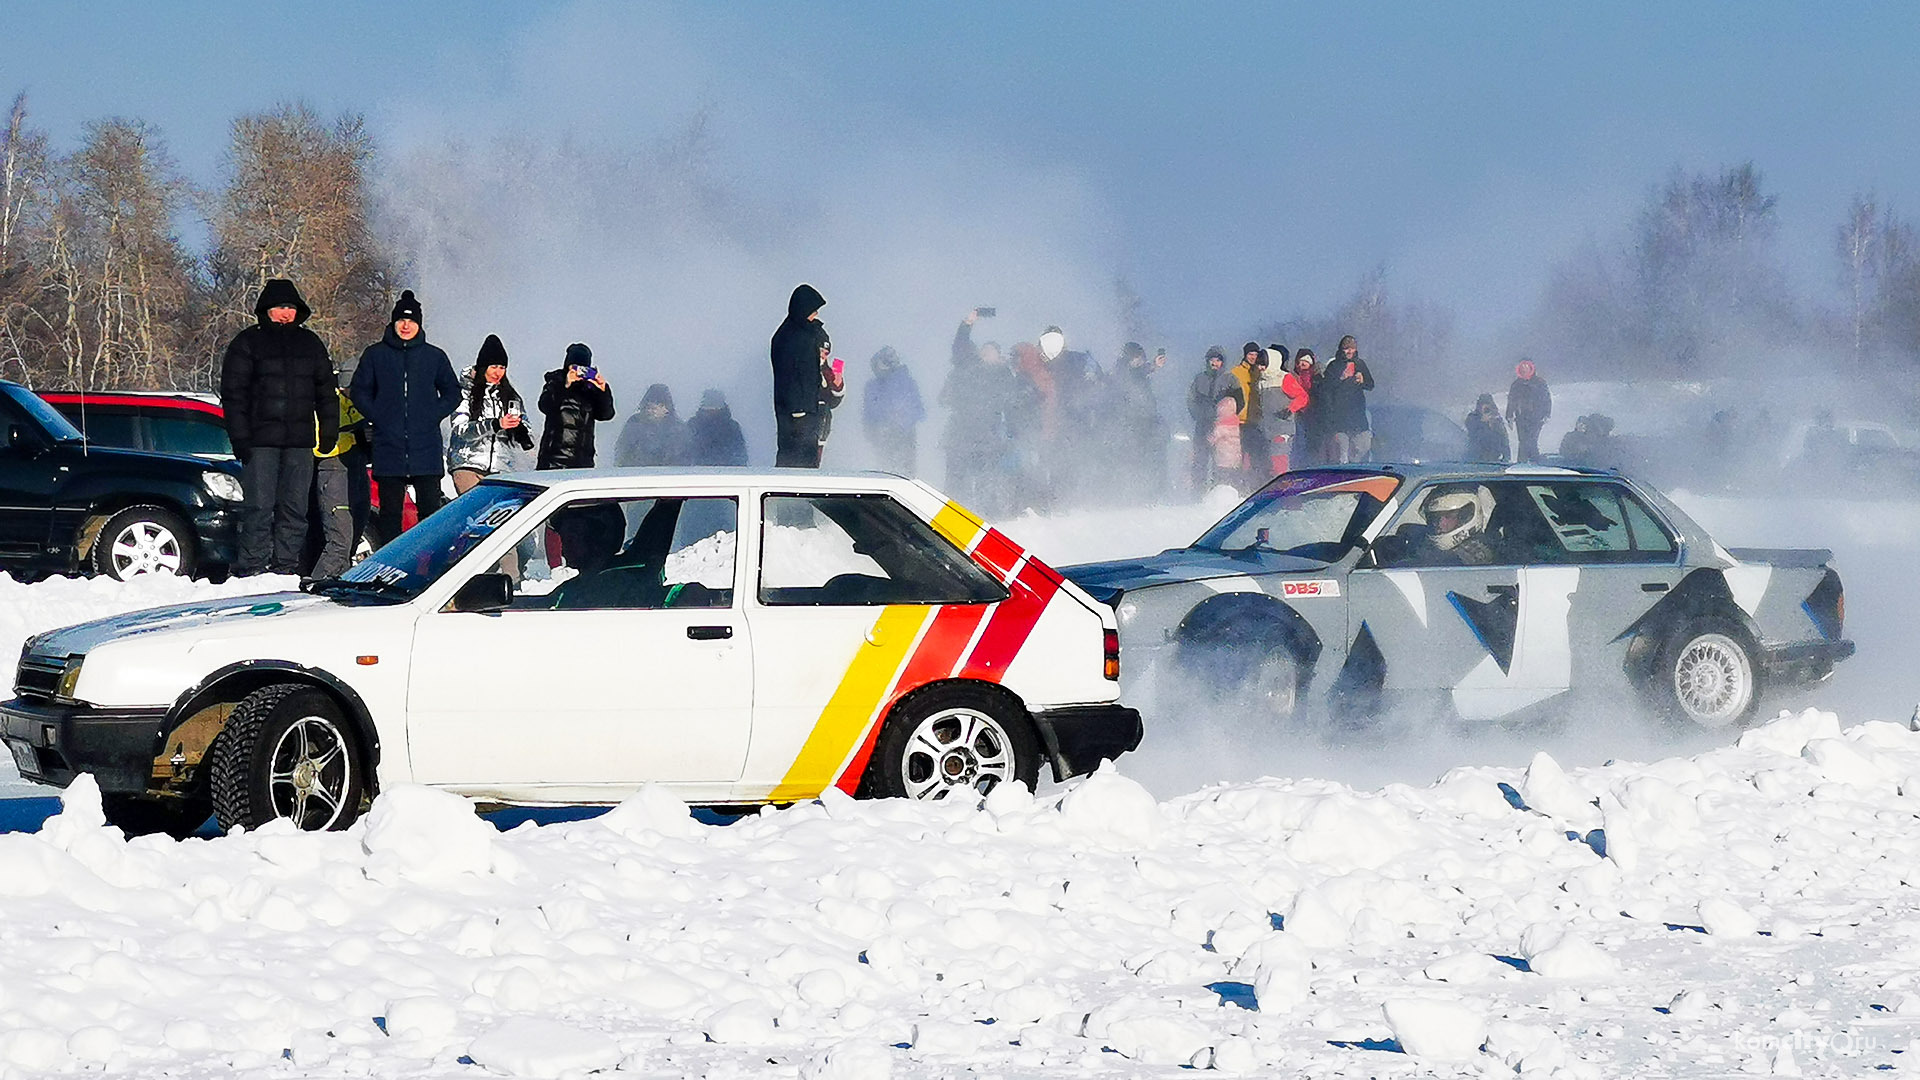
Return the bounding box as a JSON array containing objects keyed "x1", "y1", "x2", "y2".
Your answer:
[{"x1": 348, "y1": 288, "x2": 461, "y2": 544}]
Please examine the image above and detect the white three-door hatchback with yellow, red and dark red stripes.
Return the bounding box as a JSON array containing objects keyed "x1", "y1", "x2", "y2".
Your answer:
[{"x1": 0, "y1": 469, "x2": 1140, "y2": 830}]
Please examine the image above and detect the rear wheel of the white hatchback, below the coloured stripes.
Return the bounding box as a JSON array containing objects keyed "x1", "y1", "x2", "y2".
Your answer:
[{"x1": 874, "y1": 686, "x2": 1041, "y2": 799}]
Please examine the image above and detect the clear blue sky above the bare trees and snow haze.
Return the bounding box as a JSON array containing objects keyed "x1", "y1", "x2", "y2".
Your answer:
[{"x1": 15, "y1": 0, "x2": 1920, "y2": 340}]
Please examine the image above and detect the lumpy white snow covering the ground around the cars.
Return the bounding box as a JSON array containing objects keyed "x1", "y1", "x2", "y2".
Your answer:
[{"x1": 0, "y1": 496, "x2": 1920, "y2": 1078}]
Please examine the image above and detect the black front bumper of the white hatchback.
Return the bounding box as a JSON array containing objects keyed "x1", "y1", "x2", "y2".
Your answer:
[{"x1": 0, "y1": 698, "x2": 167, "y2": 794}]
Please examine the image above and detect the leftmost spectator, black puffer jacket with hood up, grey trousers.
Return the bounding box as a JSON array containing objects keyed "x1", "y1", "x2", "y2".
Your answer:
[{"x1": 221, "y1": 279, "x2": 340, "y2": 575}]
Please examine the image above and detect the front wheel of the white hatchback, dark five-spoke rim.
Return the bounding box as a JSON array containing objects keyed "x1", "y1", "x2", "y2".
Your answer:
[{"x1": 211, "y1": 682, "x2": 367, "y2": 832}]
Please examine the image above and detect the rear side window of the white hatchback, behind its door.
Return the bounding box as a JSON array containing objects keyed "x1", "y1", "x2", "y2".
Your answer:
[{"x1": 758, "y1": 496, "x2": 1006, "y2": 607}]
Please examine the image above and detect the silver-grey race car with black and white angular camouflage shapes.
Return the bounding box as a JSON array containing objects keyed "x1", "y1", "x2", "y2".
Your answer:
[{"x1": 1062, "y1": 465, "x2": 1853, "y2": 726}]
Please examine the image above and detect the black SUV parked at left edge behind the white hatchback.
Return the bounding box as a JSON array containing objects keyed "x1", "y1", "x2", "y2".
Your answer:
[{"x1": 0, "y1": 380, "x2": 242, "y2": 580}]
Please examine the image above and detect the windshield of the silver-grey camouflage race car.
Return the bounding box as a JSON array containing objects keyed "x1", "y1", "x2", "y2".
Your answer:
[{"x1": 1194, "y1": 473, "x2": 1400, "y2": 563}]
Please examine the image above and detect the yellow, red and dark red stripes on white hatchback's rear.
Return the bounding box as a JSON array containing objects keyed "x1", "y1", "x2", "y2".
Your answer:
[{"x1": 768, "y1": 502, "x2": 1060, "y2": 801}]
